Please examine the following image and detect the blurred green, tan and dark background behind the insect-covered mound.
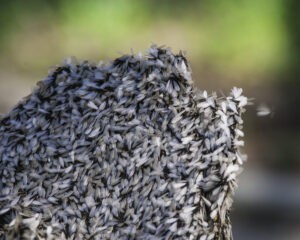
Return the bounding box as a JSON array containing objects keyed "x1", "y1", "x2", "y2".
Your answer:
[{"x1": 0, "y1": 0, "x2": 300, "y2": 240}]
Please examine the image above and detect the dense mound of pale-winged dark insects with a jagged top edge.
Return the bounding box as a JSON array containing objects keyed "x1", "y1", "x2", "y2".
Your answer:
[{"x1": 0, "y1": 46, "x2": 247, "y2": 240}]
